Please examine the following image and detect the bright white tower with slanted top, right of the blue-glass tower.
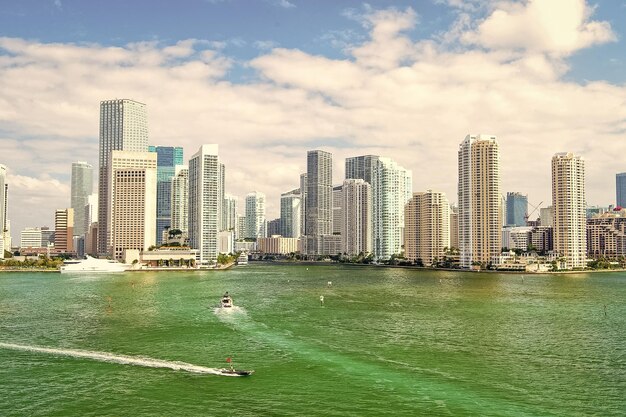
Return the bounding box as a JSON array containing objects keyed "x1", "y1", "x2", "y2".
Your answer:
[{"x1": 189, "y1": 144, "x2": 222, "y2": 266}]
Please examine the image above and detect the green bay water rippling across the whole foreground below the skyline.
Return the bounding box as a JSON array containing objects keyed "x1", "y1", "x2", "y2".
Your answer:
[{"x1": 0, "y1": 265, "x2": 626, "y2": 416}]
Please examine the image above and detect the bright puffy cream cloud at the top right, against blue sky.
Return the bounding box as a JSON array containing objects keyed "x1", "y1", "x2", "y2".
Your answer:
[{"x1": 462, "y1": 0, "x2": 616, "y2": 55}]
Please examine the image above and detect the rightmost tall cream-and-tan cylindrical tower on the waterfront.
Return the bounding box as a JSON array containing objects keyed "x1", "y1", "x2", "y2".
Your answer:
[{"x1": 552, "y1": 152, "x2": 587, "y2": 269}]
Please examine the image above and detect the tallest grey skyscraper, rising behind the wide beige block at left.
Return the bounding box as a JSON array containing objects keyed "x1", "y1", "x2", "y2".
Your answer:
[{"x1": 98, "y1": 99, "x2": 148, "y2": 254}]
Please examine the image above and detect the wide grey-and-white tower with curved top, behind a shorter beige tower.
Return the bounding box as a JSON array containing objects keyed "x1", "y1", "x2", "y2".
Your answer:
[{"x1": 346, "y1": 155, "x2": 413, "y2": 260}]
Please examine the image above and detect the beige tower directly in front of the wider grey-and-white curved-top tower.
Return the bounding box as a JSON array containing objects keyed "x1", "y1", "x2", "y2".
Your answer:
[{"x1": 339, "y1": 178, "x2": 372, "y2": 256}]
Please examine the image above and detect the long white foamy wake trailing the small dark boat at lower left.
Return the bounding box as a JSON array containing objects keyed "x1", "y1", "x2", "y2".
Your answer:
[{"x1": 0, "y1": 342, "x2": 239, "y2": 376}]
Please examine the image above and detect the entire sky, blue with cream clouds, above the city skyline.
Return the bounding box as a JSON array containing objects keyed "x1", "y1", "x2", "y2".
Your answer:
[{"x1": 0, "y1": 0, "x2": 626, "y2": 242}]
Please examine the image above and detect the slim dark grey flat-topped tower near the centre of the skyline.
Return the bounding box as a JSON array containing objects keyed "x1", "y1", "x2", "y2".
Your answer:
[{"x1": 305, "y1": 150, "x2": 334, "y2": 255}]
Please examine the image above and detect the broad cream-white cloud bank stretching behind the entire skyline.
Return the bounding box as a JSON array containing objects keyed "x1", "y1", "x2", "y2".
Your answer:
[{"x1": 0, "y1": 3, "x2": 626, "y2": 237}]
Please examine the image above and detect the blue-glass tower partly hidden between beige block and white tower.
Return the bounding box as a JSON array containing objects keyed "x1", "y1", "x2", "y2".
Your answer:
[{"x1": 148, "y1": 146, "x2": 184, "y2": 245}]
